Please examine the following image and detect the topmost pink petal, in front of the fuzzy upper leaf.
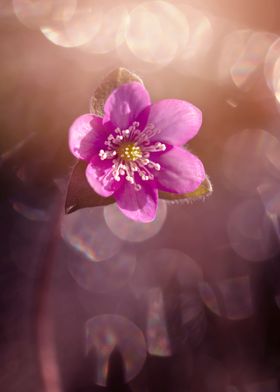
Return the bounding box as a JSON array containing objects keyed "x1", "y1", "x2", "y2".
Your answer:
[{"x1": 103, "y1": 82, "x2": 151, "y2": 129}]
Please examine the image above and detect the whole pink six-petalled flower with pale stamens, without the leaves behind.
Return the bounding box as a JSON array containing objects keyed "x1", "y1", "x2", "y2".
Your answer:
[{"x1": 69, "y1": 82, "x2": 206, "y2": 222}]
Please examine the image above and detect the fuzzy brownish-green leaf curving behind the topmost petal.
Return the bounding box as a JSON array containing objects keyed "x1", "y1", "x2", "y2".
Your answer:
[{"x1": 90, "y1": 68, "x2": 143, "y2": 117}]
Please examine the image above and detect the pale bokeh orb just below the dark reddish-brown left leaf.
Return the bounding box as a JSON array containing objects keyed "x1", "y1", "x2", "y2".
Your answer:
[{"x1": 61, "y1": 208, "x2": 122, "y2": 261}]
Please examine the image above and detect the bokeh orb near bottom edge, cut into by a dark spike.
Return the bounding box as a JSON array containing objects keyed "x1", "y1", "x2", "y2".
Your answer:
[{"x1": 85, "y1": 314, "x2": 147, "y2": 386}]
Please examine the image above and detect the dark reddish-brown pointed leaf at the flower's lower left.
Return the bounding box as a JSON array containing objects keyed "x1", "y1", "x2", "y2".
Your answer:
[{"x1": 65, "y1": 161, "x2": 115, "y2": 214}]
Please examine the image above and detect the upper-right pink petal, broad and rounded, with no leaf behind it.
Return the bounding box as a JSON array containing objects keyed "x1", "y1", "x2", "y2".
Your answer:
[{"x1": 148, "y1": 99, "x2": 202, "y2": 146}]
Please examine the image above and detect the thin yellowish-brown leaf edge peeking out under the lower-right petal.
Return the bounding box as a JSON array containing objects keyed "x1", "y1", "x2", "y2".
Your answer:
[{"x1": 159, "y1": 177, "x2": 213, "y2": 203}]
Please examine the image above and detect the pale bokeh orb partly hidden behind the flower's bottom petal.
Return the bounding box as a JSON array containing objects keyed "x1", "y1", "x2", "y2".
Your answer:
[{"x1": 104, "y1": 200, "x2": 167, "y2": 242}]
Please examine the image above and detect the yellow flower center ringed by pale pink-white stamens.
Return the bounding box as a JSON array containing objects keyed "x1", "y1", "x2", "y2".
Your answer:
[{"x1": 99, "y1": 121, "x2": 166, "y2": 191}]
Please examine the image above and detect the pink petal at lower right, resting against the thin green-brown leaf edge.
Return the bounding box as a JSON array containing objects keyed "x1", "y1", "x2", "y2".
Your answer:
[{"x1": 152, "y1": 147, "x2": 206, "y2": 193}]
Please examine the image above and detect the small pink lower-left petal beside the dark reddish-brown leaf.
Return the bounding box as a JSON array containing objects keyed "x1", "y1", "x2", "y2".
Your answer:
[{"x1": 86, "y1": 156, "x2": 121, "y2": 197}]
